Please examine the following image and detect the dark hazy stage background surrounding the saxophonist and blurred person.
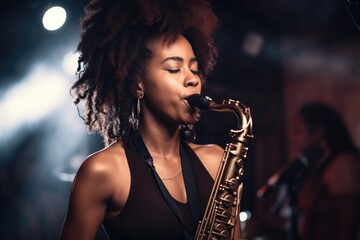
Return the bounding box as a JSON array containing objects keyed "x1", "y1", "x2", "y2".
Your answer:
[{"x1": 0, "y1": 0, "x2": 360, "y2": 239}]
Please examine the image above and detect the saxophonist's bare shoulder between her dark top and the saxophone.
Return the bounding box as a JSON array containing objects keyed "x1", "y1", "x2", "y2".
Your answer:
[{"x1": 189, "y1": 143, "x2": 224, "y2": 179}]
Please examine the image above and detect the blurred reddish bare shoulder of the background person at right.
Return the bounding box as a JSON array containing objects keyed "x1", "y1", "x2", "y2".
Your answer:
[{"x1": 323, "y1": 152, "x2": 360, "y2": 195}]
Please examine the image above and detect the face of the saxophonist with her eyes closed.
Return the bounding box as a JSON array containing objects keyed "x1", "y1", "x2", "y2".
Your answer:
[{"x1": 138, "y1": 35, "x2": 201, "y2": 124}]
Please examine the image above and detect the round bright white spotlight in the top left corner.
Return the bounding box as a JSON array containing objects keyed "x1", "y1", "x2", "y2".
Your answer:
[{"x1": 42, "y1": 6, "x2": 66, "y2": 31}]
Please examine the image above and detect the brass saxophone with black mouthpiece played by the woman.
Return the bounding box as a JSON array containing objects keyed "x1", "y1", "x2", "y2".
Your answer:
[{"x1": 188, "y1": 94, "x2": 253, "y2": 240}]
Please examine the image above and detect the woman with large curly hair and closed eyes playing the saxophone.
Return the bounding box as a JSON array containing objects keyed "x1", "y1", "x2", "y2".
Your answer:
[{"x1": 61, "y1": 0, "x2": 239, "y2": 239}]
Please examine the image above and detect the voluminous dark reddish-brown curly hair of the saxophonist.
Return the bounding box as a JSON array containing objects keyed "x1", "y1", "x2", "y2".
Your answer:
[{"x1": 71, "y1": 0, "x2": 217, "y2": 145}]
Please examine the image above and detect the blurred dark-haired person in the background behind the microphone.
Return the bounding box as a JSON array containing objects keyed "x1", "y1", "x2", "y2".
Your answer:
[{"x1": 294, "y1": 103, "x2": 360, "y2": 240}]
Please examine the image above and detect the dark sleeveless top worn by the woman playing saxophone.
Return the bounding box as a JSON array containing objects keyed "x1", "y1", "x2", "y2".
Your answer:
[{"x1": 103, "y1": 144, "x2": 214, "y2": 240}]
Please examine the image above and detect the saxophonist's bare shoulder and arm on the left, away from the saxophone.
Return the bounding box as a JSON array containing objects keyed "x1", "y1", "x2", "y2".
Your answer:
[{"x1": 61, "y1": 143, "x2": 130, "y2": 239}]
